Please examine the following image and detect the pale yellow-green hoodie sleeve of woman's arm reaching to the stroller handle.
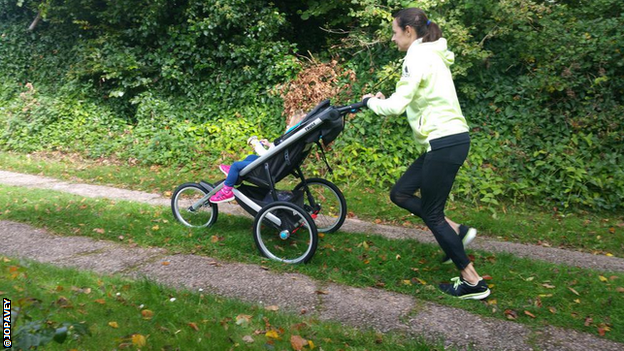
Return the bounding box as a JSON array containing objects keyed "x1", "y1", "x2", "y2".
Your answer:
[{"x1": 367, "y1": 55, "x2": 423, "y2": 116}]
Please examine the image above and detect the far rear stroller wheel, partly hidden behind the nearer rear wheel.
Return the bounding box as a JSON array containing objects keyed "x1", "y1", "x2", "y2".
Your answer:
[{"x1": 295, "y1": 178, "x2": 347, "y2": 233}]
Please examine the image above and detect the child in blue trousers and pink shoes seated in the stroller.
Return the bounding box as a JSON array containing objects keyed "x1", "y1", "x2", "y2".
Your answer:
[{"x1": 210, "y1": 111, "x2": 306, "y2": 204}]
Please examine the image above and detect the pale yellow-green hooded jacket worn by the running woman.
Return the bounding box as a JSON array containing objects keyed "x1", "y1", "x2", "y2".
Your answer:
[{"x1": 367, "y1": 38, "x2": 468, "y2": 151}]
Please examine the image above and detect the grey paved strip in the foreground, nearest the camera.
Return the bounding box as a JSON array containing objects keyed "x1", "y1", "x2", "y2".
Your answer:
[{"x1": 0, "y1": 221, "x2": 624, "y2": 351}]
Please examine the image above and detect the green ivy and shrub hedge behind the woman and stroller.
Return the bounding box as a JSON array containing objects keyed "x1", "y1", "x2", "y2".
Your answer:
[{"x1": 0, "y1": 0, "x2": 624, "y2": 210}]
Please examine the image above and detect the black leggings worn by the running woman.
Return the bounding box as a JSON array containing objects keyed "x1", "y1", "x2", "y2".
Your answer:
[{"x1": 390, "y1": 143, "x2": 470, "y2": 270}]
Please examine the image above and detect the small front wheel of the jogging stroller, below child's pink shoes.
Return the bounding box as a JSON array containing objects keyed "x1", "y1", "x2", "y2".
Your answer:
[{"x1": 171, "y1": 183, "x2": 219, "y2": 228}]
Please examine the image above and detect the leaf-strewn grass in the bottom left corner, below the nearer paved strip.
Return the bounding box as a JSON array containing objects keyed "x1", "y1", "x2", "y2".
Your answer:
[{"x1": 0, "y1": 257, "x2": 444, "y2": 351}]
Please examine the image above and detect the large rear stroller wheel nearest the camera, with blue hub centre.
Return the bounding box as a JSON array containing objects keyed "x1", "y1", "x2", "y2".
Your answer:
[{"x1": 253, "y1": 201, "x2": 318, "y2": 263}]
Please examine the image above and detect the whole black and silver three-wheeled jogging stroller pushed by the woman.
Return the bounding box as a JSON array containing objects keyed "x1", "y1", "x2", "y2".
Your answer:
[{"x1": 171, "y1": 100, "x2": 365, "y2": 263}]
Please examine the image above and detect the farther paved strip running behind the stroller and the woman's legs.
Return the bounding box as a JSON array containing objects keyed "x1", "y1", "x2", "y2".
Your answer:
[{"x1": 0, "y1": 171, "x2": 624, "y2": 272}]
